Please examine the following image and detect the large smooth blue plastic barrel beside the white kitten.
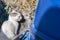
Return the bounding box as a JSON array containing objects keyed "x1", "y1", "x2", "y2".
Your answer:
[{"x1": 30, "y1": 0, "x2": 60, "y2": 40}]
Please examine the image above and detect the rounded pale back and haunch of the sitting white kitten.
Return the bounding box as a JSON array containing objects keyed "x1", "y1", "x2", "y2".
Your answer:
[{"x1": 1, "y1": 21, "x2": 15, "y2": 39}]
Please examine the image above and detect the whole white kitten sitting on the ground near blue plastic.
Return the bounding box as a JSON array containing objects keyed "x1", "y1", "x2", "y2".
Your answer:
[{"x1": 2, "y1": 10, "x2": 22, "y2": 39}]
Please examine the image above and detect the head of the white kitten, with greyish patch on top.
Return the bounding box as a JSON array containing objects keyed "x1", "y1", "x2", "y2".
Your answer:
[{"x1": 9, "y1": 10, "x2": 22, "y2": 21}]
